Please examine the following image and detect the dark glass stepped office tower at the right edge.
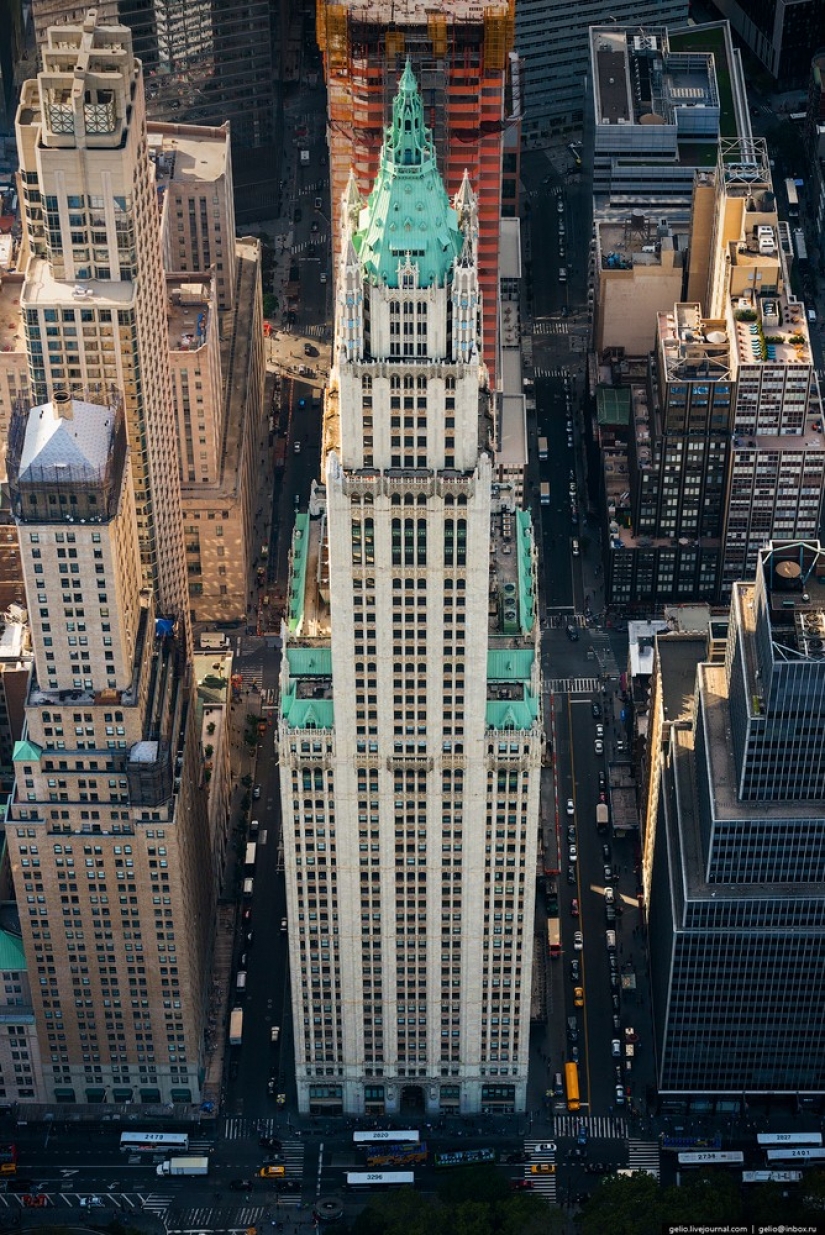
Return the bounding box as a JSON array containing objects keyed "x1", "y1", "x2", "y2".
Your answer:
[{"x1": 645, "y1": 541, "x2": 825, "y2": 1109}]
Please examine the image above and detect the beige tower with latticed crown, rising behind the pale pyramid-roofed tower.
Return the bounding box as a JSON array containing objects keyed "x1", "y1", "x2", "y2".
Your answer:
[{"x1": 16, "y1": 10, "x2": 189, "y2": 636}]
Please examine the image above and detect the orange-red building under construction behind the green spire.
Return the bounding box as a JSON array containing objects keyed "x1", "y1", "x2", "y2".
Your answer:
[{"x1": 316, "y1": 0, "x2": 520, "y2": 383}]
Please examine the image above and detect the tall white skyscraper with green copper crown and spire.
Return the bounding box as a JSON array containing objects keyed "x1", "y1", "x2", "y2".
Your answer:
[{"x1": 278, "y1": 61, "x2": 543, "y2": 1113}]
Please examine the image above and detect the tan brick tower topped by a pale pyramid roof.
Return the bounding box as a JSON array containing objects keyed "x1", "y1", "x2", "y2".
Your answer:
[{"x1": 6, "y1": 393, "x2": 212, "y2": 1104}]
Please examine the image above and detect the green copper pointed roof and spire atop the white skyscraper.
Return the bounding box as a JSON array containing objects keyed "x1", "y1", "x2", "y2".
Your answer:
[{"x1": 353, "y1": 61, "x2": 464, "y2": 288}]
